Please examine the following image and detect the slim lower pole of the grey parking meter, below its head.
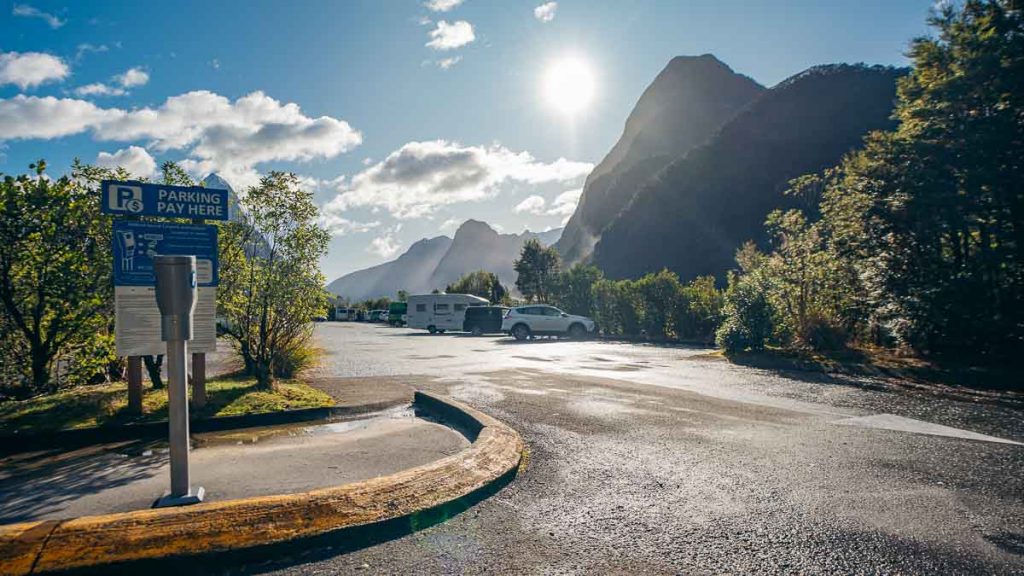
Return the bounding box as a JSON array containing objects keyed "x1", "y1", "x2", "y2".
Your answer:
[{"x1": 167, "y1": 340, "x2": 191, "y2": 498}]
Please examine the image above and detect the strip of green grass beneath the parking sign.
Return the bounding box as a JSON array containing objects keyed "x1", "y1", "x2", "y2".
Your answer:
[{"x1": 0, "y1": 375, "x2": 334, "y2": 434}]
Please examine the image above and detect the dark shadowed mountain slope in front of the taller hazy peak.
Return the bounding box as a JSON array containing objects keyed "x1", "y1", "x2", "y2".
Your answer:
[{"x1": 593, "y1": 65, "x2": 906, "y2": 281}]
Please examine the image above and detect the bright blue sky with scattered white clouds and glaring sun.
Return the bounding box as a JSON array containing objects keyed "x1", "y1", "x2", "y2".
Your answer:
[{"x1": 0, "y1": 0, "x2": 932, "y2": 280}]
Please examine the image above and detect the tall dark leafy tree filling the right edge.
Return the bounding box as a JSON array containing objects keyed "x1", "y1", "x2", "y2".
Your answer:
[{"x1": 798, "y1": 0, "x2": 1024, "y2": 359}]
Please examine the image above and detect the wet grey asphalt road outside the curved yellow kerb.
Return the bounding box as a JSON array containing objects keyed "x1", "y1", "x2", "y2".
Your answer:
[{"x1": 260, "y1": 323, "x2": 1024, "y2": 574}]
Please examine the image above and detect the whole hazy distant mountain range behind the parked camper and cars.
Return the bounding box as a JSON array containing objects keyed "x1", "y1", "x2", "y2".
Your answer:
[{"x1": 327, "y1": 219, "x2": 561, "y2": 302}]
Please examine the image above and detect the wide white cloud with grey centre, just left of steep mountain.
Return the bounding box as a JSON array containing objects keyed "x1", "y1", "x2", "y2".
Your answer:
[{"x1": 325, "y1": 140, "x2": 593, "y2": 218}]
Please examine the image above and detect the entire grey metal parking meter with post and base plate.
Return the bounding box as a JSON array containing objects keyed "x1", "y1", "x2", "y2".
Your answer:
[{"x1": 153, "y1": 255, "x2": 204, "y2": 507}]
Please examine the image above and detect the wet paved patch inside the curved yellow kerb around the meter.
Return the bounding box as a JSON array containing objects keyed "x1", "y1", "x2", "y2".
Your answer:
[{"x1": 0, "y1": 408, "x2": 469, "y2": 524}]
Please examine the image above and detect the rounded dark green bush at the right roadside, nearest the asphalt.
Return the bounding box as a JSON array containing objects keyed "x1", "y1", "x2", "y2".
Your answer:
[{"x1": 715, "y1": 272, "x2": 775, "y2": 352}]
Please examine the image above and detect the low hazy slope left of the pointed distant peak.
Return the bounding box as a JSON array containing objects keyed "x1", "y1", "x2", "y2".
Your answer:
[{"x1": 327, "y1": 236, "x2": 452, "y2": 301}]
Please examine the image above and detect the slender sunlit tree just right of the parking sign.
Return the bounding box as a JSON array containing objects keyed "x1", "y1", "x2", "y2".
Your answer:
[{"x1": 219, "y1": 171, "x2": 330, "y2": 387}]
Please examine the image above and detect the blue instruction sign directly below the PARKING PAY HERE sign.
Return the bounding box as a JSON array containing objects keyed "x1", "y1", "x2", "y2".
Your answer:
[{"x1": 113, "y1": 220, "x2": 220, "y2": 286}]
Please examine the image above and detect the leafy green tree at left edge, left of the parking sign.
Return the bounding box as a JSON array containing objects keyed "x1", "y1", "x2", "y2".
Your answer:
[{"x1": 0, "y1": 160, "x2": 113, "y2": 396}]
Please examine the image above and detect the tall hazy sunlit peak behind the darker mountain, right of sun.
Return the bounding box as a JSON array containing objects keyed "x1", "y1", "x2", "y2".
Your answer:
[{"x1": 555, "y1": 54, "x2": 764, "y2": 263}]
